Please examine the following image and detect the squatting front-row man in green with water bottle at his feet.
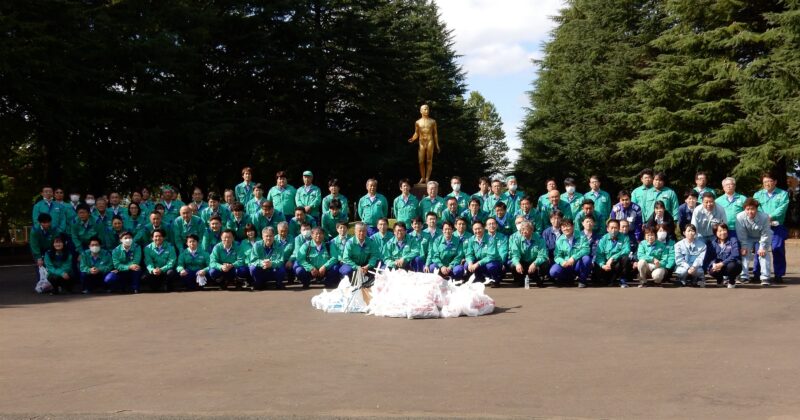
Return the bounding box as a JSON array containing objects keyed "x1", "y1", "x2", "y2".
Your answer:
[{"x1": 509, "y1": 220, "x2": 550, "y2": 287}]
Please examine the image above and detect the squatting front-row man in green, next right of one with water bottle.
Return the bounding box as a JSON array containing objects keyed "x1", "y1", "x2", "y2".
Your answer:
[{"x1": 550, "y1": 219, "x2": 591, "y2": 288}]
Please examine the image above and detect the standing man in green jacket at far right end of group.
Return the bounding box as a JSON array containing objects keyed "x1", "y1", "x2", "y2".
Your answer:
[{"x1": 753, "y1": 173, "x2": 789, "y2": 284}]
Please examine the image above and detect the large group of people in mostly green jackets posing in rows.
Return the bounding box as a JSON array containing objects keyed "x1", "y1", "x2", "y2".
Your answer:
[{"x1": 30, "y1": 167, "x2": 789, "y2": 294}]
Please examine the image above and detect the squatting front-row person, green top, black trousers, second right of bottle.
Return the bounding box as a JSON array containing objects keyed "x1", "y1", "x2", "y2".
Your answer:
[{"x1": 593, "y1": 219, "x2": 631, "y2": 288}]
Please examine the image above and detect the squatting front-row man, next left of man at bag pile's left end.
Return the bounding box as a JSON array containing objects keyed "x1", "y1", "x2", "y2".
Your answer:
[{"x1": 252, "y1": 226, "x2": 286, "y2": 290}]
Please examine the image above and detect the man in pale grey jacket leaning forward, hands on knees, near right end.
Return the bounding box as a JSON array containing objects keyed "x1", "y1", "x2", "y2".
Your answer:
[{"x1": 736, "y1": 198, "x2": 775, "y2": 287}]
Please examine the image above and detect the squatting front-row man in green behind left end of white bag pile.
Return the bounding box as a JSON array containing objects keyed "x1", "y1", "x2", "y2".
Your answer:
[{"x1": 295, "y1": 227, "x2": 339, "y2": 289}]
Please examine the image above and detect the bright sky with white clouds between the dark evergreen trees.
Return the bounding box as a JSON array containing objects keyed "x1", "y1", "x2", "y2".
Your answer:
[{"x1": 436, "y1": 0, "x2": 564, "y2": 166}]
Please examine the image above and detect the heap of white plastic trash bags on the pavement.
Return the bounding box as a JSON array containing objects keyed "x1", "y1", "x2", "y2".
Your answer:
[{"x1": 311, "y1": 270, "x2": 495, "y2": 319}]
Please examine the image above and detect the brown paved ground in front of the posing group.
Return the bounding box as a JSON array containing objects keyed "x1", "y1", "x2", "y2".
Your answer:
[{"x1": 0, "y1": 244, "x2": 800, "y2": 419}]
